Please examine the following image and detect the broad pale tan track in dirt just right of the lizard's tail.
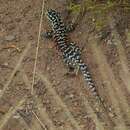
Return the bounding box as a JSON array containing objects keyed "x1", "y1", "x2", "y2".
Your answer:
[{"x1": 89, "y1": 36, "x2": 129, "y2": 130}]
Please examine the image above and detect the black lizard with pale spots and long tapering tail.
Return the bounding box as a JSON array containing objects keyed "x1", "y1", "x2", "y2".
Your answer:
[{"x1": 43, "y1": 9, "x2": 111, "y2": 115}]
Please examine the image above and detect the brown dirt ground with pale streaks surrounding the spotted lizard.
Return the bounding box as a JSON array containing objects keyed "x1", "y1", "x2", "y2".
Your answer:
[{"x1": 0, "y1": 0, "x2": 130, "y2": 130}]
